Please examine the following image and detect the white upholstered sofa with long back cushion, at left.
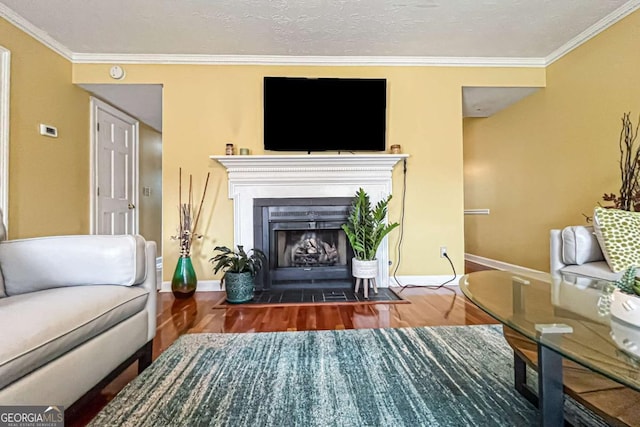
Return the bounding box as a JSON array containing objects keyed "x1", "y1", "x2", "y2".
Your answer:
[{"x1": 0, "y1": 212, "x2": 156, "y2": 415}]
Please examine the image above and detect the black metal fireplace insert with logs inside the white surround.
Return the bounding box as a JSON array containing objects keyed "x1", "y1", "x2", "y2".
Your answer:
[{"x1": 253, "y1": 197, "x2": 353, "y2": 290}]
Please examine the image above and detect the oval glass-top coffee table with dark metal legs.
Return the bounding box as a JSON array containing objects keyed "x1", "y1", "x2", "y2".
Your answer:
[{"x1": 460, "y1": 270, "x2": 640, "y2": 426}]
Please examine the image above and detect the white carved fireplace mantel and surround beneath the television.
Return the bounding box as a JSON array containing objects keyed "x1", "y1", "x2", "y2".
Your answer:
[{"x1": 210, "y1": 154, "x2": 408, "y2": 286}]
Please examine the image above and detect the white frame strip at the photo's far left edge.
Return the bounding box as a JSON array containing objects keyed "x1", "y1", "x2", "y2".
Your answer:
[{"x1": 0, "y1": 46, "x2": 11, "y2": 230}]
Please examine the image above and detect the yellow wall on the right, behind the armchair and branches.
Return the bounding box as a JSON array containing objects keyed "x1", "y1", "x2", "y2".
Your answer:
[{"x1": 464, "y1": 12, "x2": 640, "y2": 271}]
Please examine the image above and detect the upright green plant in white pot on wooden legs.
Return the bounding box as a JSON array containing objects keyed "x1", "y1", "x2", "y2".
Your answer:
[{"x1": 342, "y1": 188, "x2": 399, "y2": 298}]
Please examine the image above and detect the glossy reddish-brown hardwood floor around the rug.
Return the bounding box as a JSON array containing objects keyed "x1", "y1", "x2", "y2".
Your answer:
[{"x1": 66, "y1": 263, "x2": 497, "y2": 426}]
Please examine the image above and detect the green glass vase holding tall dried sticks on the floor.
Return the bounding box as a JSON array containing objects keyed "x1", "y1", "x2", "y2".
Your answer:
[{"x1": 171, "y1": 168, "x2": 209, "y2": 298}]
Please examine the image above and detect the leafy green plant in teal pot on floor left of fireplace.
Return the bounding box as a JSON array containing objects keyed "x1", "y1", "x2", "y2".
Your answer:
[{"x1": 209, "y1": 245, "x2": 267, "y2": 304}]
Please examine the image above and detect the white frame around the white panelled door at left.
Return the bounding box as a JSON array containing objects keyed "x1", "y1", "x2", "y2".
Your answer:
[{"x1": 89, "y1": 96, "x2": 140, "y2": 234}]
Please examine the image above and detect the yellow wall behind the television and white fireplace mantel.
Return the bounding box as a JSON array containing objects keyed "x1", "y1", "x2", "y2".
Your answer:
[{"x1": 73, "y1": 64, "x2": 545, "y2": 280}]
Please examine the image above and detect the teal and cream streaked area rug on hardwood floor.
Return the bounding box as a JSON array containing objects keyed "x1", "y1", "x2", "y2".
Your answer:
[{"x1": 90, "y1": 325, "x2": 604, "y2": 427}]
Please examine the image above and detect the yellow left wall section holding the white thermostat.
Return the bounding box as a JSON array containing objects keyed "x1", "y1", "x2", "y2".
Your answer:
[{"x1": 0, "y1": 19, "x2": 89, "y2": 238}]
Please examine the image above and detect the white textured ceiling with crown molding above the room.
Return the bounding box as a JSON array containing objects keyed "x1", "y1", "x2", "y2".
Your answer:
[{"x1": 0, "y1": 0, "x2": 640, "y2": 129}]
